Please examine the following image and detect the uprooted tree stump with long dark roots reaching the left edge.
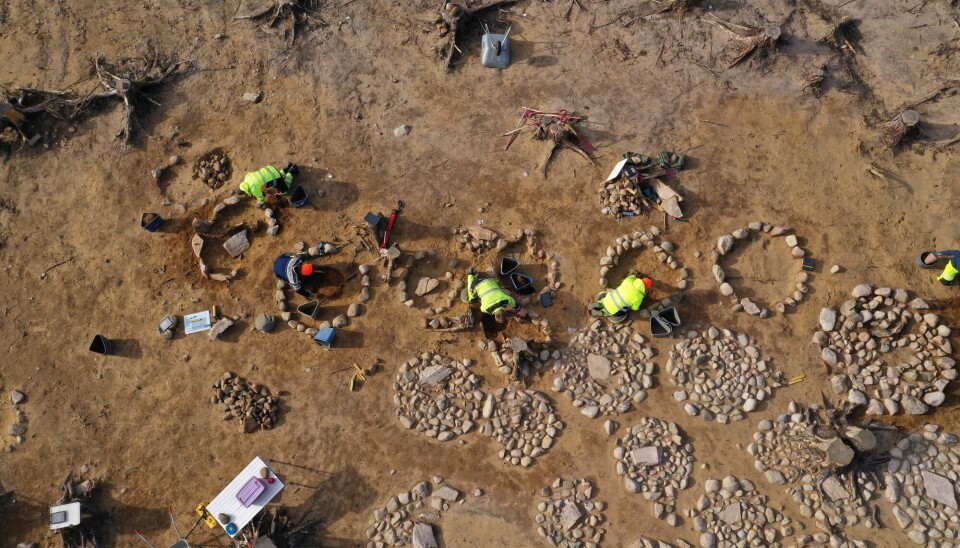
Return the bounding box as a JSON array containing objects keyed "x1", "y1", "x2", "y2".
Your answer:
[{"x1": 0, "y1": 55, "x2": 190, "y2": 145}]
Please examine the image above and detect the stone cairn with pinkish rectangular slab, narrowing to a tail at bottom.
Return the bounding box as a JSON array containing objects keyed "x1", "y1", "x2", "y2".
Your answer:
[{"x1": 613, "y1": 417, "x2": 693, "y2": 524}]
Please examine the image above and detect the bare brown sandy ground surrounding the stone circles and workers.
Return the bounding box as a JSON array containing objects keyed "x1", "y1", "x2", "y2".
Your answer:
[{"x1": 0, "y1": 0, "x2": 960, "y2": 546}]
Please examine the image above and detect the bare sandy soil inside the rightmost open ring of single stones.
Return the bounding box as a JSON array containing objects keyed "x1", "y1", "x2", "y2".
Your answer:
[{"x1": 719, "y1": 234, "x2": 800, "y2": 308}]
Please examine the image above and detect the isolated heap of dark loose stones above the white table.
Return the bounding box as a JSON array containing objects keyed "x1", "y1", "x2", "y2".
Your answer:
[{"x1": 210, "y1": 371, "x2": 280, "y2": 434}]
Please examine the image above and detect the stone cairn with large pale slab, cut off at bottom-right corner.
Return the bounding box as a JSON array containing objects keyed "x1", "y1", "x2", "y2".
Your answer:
[{"x1": 885, "y1": 424, "x2": 960, "y2": 546}]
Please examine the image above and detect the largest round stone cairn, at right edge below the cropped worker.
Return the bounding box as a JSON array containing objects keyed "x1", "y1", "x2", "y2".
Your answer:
[{"x1": 813, "y1": 284, "x2": 957, "y2": 415}]
